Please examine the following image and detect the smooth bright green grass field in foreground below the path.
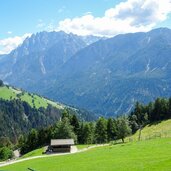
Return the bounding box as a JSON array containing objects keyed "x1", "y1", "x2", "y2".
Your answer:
[{"x1": 0, "y1": 138, "x2": 171, "y2": 171}]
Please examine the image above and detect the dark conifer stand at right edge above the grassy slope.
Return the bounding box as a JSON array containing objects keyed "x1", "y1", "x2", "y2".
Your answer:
[{"x1": 128, "y1": 98, "x2": 171, "y2": 133}]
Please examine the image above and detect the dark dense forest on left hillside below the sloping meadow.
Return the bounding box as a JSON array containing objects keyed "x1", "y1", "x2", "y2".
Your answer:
[{"x1": 0, "y1": 99, "x2": 61, "y2": 140}]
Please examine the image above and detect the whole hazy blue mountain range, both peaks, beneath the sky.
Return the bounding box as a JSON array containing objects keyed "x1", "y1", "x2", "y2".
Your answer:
[{"x1": 0, "y1": 28, "x2": 171, "y2": 116}]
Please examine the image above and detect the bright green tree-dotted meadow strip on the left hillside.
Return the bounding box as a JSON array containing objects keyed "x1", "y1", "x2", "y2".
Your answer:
[{"x1": 0, "y1": 86, "x2": 64, "y2": 109}]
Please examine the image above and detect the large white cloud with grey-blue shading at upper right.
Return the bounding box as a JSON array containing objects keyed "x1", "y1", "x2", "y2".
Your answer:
[{"x1": 57, "y1": 0, "x2": 171, "y2": 37}]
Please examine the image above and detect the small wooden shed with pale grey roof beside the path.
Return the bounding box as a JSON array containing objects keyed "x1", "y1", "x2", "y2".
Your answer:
[{"x1": 50, "y1": 139, "x2": 74, "y2": 153}]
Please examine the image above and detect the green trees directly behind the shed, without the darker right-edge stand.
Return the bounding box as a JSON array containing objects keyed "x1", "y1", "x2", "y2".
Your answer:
[{"x1": 18, "y1": 110, "x2": 131, "y2": 154}]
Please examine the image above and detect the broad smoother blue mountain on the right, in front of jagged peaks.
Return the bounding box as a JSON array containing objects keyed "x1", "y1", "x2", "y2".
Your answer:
[{"x1": 40, "y1": 28, "x2": 171, "y2": 115}]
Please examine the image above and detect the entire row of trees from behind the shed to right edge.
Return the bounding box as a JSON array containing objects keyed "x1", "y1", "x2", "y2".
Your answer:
[{"x1": 0, "y1": 98, "x2": 171, "y2": 160}]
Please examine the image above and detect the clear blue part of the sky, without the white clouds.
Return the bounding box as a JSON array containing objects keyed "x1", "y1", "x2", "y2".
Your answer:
[{"x1": 0, "y1": 0, "x2": 123, "y2": 39}]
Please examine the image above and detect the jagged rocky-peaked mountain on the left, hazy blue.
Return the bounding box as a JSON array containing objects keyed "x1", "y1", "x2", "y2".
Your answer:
[{"x1": 0, "y1": 31, "x2": 99, "y2": 89}]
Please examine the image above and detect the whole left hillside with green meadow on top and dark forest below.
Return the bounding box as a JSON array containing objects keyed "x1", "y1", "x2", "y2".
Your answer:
[{"x1": 0, "y1": 81, "x2": 96, "y2": 142}]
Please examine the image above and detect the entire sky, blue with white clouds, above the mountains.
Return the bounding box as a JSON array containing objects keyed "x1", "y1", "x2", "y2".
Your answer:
[{"x1": 0, "y1": 0, "x2": 171, "y2": 54}]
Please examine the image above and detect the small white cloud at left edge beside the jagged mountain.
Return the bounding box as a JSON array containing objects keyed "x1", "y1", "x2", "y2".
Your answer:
[{"x1": 0, "y1": 33, "x2": 31, "y2": 54}]
